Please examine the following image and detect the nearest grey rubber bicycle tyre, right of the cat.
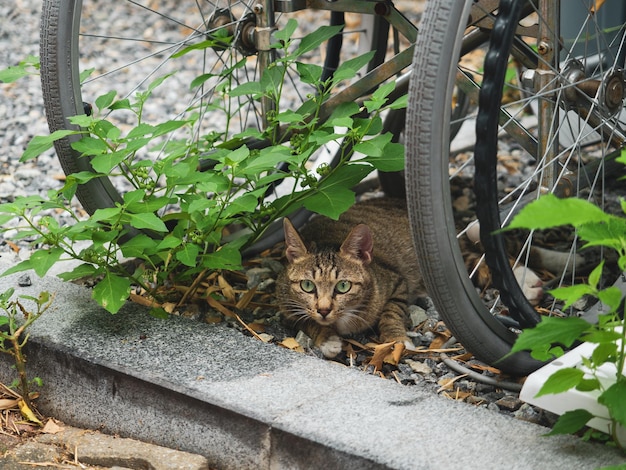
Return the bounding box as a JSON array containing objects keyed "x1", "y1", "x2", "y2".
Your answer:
[{"x1": 406, "y1": 0, "x2": 541, "y2": 375}]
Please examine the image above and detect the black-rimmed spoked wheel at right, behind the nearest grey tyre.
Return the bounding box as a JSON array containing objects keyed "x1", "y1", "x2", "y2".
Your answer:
[{"x1": 476, "y1": 0, "x2": 626, "y2": 340}]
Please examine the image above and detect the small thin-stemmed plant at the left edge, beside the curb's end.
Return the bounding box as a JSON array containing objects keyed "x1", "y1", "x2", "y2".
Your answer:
[{"x1": 0, "y1": 289, "x2": 53, "y2": 419}]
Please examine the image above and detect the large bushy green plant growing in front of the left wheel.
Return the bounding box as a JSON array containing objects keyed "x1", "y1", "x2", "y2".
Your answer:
[{"x1": 0, "y1": 20, "x2": 406, "y2": 316}]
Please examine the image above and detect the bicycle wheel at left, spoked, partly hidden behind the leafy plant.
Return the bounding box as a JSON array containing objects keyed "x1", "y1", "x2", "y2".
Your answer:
[{"x1": 41, "y1": 0, "x2": 410, "y2": 242}]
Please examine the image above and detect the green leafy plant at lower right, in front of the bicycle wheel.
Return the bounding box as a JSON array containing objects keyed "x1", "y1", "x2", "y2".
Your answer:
[{"x1": 509, "y1": 192, "x2": 626, "y2": 450}]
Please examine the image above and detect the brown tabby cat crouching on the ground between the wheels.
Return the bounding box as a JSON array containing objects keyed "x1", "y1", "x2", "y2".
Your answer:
[{"x1": 277, "y1": 198, "x2": 426, "y2": 358}]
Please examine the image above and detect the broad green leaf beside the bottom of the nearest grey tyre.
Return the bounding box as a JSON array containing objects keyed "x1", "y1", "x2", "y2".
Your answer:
[{"x1": 511, "y1": 317, "x2": 592, "y2": 361}]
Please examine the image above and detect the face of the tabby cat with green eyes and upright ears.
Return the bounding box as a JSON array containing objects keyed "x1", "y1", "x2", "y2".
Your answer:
[{"x1": 281, "y1": 219, "x2": 372, "y2": 334}]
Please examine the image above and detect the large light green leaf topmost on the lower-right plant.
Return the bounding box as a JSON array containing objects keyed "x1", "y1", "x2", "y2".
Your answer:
[{"x1": 506, "y1": 194, "x2": 609, "y2": 230}]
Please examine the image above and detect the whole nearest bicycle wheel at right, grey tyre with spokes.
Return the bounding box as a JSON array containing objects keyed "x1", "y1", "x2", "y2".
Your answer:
[{"x1": 407, "y1": 0, "x2": 623, "y2": 375}]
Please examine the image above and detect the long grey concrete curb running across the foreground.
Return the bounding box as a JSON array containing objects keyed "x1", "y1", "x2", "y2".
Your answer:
[{"x1": 0, "y1": 268, "x2": 624, "y2": 469}]
